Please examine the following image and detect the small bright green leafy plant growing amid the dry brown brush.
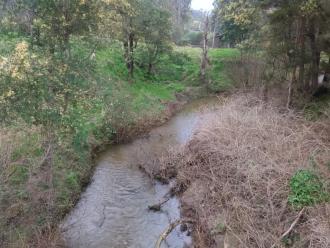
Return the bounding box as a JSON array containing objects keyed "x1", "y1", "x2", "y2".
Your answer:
[{"x1": 288, "y1": 170, "x2": 329, "y2": 208}]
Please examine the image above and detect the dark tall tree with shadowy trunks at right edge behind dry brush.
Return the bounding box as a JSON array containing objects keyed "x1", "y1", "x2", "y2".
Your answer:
[{"x1": 264, "y1": 0, "x2": 329, "y2": 93}]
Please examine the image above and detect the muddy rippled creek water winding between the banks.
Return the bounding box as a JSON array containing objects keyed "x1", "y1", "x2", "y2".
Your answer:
[{"x1": 61, "y1": 98, "x2": 217, "y2": 248}]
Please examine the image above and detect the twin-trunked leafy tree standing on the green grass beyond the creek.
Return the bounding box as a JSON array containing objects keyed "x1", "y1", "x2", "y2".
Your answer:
[{"x1": 104, "y1": 0, "x2": 171, "y2": 78}]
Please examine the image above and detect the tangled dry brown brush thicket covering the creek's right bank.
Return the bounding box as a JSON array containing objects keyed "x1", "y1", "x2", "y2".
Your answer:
[{"x1": 158, "y1": 95, "x2": 330, "y2": 248}]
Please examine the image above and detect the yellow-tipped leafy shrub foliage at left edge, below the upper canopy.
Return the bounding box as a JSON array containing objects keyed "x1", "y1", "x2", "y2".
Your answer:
[{"x1": 0, "y1": 38, "x2": 93, "y2": 132}]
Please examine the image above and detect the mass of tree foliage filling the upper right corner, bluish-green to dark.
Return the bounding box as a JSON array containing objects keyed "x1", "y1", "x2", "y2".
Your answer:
[{"x1": 214, "y1": 0, "x2": 330, "y2": 96}]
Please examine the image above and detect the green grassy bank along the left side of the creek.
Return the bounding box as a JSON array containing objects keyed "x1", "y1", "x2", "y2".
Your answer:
[{"x1": 0, "y1": 34, "x2": 240, "y2": 247}]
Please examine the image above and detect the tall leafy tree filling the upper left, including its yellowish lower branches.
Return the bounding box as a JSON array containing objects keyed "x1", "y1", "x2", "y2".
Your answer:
[{"x1": 0, "y1": 0, "x2": 97, "y2": 130}]
